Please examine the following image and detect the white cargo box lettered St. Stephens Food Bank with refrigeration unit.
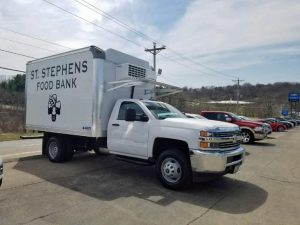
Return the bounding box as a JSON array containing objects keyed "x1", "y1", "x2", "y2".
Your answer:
[{"x1": 26, "y1": 46, "x2": 155, "y2": 137}]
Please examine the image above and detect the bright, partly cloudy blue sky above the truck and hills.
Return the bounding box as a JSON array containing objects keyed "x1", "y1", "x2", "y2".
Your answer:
[{"x1": 0, "y1": 0, "x2": 300, "y2": 88}]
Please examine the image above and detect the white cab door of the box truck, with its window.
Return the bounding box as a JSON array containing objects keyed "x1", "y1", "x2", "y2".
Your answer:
[{"x1": 108, "y1": 101, "x2": 149, "y2": 158}]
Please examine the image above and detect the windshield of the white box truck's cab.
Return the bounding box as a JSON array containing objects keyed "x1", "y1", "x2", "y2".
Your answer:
[{"x1": 144, "y1": 101, "x2": 187, "y2": 120}]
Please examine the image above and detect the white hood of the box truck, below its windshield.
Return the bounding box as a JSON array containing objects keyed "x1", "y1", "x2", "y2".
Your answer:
[{"x1": 160, "y1": 118, "x2": 239, "y2": 131}]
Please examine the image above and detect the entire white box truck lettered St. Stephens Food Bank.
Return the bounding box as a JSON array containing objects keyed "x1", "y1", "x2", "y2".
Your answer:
[{"x1": 26, "y1": 46, "x2": 245, "y2": 189}]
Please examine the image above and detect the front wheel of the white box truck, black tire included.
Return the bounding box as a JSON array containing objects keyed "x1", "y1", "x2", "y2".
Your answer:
[{"x1": 156, "y1": 149, "x2": 192, "y2": 190}]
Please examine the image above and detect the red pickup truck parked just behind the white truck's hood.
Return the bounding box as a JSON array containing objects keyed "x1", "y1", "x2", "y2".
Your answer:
[{"x1": 201, "y1": 111, "x2": 267, "y2": 144}]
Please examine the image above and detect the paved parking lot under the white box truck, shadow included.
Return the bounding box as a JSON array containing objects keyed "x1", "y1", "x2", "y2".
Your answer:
[{"x1": 0, "y1": 127, "x2": 300, "y2": 225}]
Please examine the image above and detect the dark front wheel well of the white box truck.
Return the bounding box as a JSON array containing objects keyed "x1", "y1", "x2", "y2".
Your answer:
[{"x1": 153, "y1": 138, "x2": 189, "y2": 160}]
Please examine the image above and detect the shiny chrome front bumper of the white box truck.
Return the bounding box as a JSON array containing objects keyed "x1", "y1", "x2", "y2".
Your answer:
[{"x1": 190, "y1": 147, "x2": 245, "y2": 173}]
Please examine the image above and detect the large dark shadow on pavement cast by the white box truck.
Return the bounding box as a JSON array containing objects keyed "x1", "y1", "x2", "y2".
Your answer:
[{"x1": 14, "y1": 154, "x2": 268, "y2": 214}]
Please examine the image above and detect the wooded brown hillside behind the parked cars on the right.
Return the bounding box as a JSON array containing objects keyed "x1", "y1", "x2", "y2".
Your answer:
[{"x1": 158, "y1": 82, "x2": 300, "y2": 117}]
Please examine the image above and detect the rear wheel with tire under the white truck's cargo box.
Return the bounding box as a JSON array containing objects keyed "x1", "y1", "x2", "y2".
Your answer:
[{"x1": 46, "y1": 136, "x2": 64, "y2": 162}]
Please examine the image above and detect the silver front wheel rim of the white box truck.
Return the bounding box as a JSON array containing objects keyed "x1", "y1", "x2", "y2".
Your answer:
[{"x1": 161, "y1": 158, "x2": 182, "y2": 183}]
